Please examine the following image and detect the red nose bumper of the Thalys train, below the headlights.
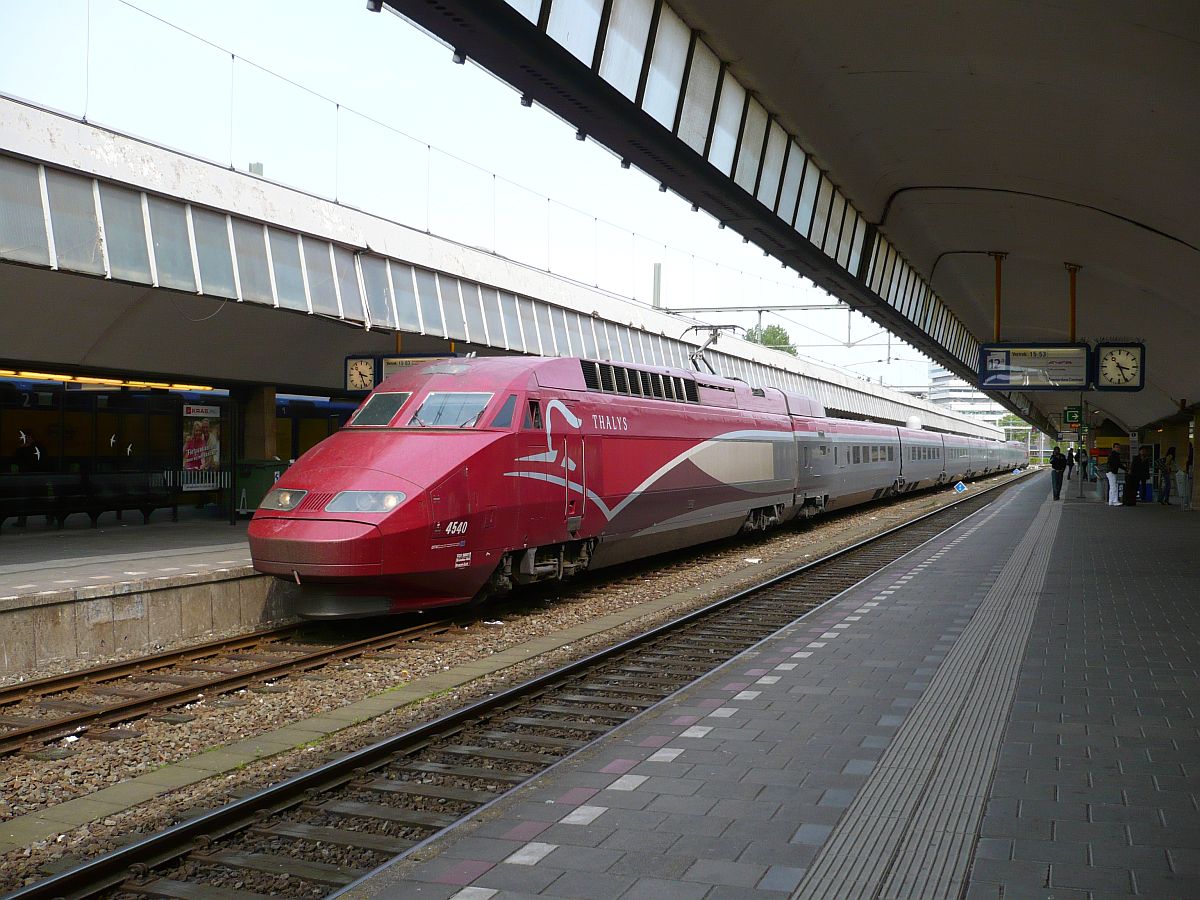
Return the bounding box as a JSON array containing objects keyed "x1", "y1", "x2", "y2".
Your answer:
[{"x1": 247, "y1": 516, "x2": 383, "y2": 578}]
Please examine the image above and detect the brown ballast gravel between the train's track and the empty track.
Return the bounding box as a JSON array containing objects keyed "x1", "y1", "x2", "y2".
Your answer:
[{"x1": 0, "y1": 475, "x2": 1013, "y2": 890}]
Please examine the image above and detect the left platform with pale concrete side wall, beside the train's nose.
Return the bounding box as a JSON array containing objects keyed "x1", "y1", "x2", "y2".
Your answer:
[{"x1": 0, "y1": 508, "x2": 274, "y2": 679}]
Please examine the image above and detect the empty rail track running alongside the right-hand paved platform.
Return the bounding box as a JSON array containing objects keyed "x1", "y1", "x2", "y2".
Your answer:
[{"x1": 8, "y1": 482, "x2": 1032, "y2": 900}]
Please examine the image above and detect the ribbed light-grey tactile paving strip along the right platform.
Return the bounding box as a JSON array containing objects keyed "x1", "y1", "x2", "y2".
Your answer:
[{"x1": 792, "y1": 503, "x2": 1061, "y2": 900}]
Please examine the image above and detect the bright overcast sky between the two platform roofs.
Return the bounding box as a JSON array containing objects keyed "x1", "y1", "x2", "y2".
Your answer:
[{"x1": 0, "y1": 0, "x2": 928, "y2": 385}]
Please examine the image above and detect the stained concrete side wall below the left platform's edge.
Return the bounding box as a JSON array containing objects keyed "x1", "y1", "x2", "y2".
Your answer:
[{"x1": 0, "y1": 566, "x2": 293, "y2": 674}]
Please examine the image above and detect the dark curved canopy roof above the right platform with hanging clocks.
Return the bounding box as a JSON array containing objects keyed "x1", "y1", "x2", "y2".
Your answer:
[{"x1": 386, "y1": 0, "x2": 1200, "y2": 428}]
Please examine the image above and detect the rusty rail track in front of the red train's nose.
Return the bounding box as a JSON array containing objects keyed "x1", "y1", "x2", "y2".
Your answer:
[{"x1": 0, "y1": 619, "x2": 463, "y2": 756}]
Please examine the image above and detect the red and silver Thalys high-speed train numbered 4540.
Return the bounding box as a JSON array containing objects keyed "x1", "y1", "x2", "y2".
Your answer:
[{"x1": 250, "y1": 356, "x2": 1026, "y2": 618}]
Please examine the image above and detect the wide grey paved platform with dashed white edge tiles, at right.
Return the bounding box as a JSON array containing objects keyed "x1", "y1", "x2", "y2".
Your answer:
[{"x1": 338, "y1": 474, "x2": 1200, "y2": 900}]
